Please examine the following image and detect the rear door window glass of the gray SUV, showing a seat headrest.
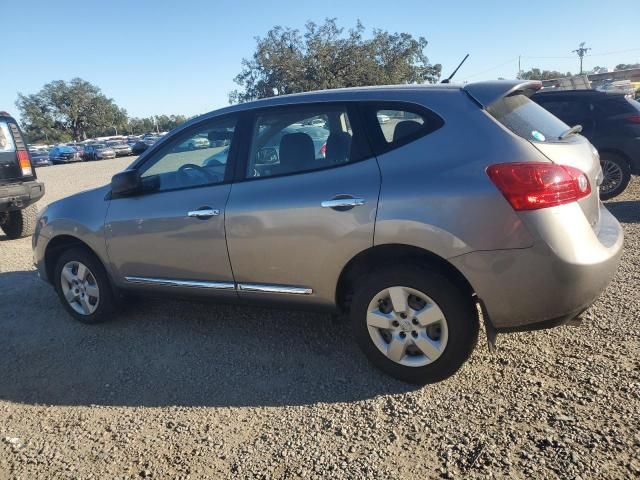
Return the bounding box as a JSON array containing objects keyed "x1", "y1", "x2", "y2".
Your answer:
[{"x1": 246, "y1": 106, "x2": 363, "y2": 178}]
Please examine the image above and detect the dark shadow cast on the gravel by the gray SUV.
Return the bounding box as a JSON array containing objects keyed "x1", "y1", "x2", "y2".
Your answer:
[{"x1": 0, "y1": 271, "x2": 412, "y2": 406}]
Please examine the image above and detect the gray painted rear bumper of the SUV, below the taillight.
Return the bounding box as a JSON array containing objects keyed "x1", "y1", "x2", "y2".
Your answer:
[{"x1": 450, "y1": 204, "x2": 623, "y2": 331}]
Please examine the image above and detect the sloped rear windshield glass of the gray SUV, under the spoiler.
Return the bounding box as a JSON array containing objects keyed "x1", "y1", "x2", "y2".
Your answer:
[{"x1": 487, "y1": 94, "x2": 569, "y2": 142}]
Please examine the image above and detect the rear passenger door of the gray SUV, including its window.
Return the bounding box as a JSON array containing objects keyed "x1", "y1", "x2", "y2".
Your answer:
[{"x1": 226, "y1": 104, "x2": 380, "y2": 305}]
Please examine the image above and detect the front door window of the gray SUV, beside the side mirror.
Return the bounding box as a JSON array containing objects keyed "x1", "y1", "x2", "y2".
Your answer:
[{"x1": 139, "y1": 116, "x2": 237, "y2": 191}]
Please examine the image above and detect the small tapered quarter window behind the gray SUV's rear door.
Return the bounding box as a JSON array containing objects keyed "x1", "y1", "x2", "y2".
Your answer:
[{"x1": 363, "y1": 102, "x2": 444, "y2": 154}]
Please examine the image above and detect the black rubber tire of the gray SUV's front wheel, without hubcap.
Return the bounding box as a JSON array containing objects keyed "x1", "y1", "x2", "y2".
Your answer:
[{"x1": 53, "y1": 248, "x2": 115, "y2": 324}]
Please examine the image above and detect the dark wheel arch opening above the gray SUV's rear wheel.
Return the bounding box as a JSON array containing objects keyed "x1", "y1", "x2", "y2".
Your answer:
[{"x1": 336, "y1": 244, "x2": 475, "y2": 311}]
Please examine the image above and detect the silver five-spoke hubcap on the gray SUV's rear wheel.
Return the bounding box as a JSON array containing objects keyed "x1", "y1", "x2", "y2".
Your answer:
[{"x1": 367, "y1": 286, "x2": 448, "y2": 367}]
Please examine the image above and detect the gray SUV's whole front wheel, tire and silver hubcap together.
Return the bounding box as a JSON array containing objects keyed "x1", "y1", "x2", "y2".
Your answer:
[{"x1": 54, "y1": 248, "x2": 116, "y2": 323}]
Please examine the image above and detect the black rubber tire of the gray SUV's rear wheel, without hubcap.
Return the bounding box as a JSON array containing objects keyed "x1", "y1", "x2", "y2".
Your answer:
[{"x1": 351, "y1": 266, "x2": 478, "y2": 384}]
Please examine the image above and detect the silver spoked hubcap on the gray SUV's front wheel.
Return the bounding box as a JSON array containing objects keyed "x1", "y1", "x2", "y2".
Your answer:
[{"x1": 60, "y1": 261, "x2": 100, "y2": 315}]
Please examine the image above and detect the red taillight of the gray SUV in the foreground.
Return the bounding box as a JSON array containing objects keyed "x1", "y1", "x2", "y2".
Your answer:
[{"x1": 487, "y1": 162, "x2": 591, "y2": 210}]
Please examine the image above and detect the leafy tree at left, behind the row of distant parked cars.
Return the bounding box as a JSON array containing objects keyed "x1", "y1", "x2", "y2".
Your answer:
[{"x1": 16, "y1": 78, "x2": 127, "y2": 141}]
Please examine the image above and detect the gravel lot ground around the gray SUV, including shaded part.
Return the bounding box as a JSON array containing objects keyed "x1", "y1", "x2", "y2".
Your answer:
[{"x1": 0, "y1": 159, "x2": 640, "y2": 479}]
